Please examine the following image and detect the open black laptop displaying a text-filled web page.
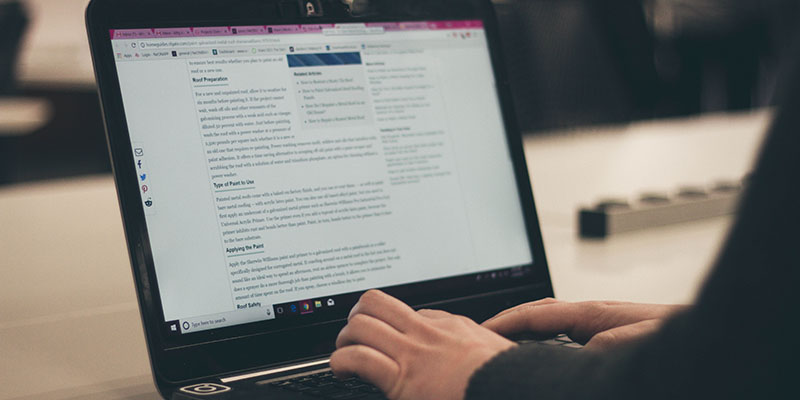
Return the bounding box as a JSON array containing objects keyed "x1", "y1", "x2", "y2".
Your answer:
[{"x1": 86, "y1": 0, "x2": 553, "y2": 399}]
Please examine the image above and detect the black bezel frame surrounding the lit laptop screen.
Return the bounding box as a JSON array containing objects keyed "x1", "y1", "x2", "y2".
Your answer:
[{"x1": 87, "y1": 0, "x2": 553, "y2": 383}]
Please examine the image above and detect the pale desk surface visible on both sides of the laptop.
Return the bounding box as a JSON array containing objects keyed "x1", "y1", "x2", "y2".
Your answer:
[{"x1": 0, "y1": 112, "x2": 770, "y2": 400}]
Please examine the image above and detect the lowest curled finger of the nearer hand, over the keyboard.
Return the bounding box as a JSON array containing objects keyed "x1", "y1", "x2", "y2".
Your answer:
[{"x1": 330, "y1": 345, "x2": 400, "y2": 393}]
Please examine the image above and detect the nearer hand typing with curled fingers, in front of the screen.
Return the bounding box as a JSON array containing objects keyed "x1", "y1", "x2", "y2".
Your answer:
[{"x1": 331, "y1": 290, "x2": 516, "y2": 400}]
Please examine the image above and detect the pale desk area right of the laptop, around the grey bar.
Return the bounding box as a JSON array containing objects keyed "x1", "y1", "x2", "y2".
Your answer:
[{"x1": 524, "y1": 109, "x2": 773, "y2": 303}]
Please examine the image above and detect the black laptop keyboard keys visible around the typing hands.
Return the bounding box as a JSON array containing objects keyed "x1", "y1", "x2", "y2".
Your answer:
[{"x1": 269, "y1": 335, "x2": 583, "y2": 400}]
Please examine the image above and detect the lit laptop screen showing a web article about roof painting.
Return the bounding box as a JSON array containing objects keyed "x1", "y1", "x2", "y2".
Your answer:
[{"x1": 110, "y1": 20, "x2": 533, "y2": 335}]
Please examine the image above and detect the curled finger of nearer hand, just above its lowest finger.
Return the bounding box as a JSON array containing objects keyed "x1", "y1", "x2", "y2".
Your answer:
[{"x1": 336, "y1": 314, "x2": 408, "y2": 359}]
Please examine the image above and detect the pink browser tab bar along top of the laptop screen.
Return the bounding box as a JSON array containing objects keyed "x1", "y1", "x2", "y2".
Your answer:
[{"x1": 109, "y1": 20, "x2": 483, "y2": 40}]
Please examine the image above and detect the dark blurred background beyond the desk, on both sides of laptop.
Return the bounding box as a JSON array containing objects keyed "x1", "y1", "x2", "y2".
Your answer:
[{"x1": 0, "y1": 0, "x2": 800, "y2": 185}]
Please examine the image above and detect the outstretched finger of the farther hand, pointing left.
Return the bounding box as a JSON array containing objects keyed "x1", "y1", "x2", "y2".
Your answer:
[{"x1": 482, "y1": 302, "x2": 581, "y2": 336}]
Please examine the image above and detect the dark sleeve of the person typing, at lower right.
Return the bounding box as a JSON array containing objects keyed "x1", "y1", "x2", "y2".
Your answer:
[{"x1": 466, "y1": 35, "x2": 800, "y2": 400}]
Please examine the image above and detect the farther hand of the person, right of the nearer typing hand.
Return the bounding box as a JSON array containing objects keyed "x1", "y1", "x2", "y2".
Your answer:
[{"x1": 482, "y1": 298, "x2": 685, "y2": 349}]
